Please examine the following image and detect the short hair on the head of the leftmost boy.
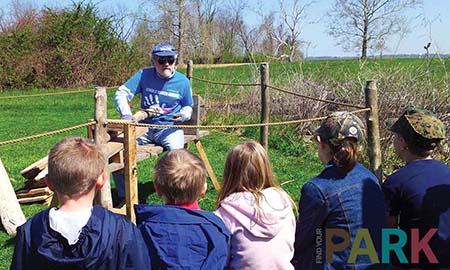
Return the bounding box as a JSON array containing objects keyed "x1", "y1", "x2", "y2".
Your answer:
[{"x1": 48, "y1": 137, "x2": 106, "y2": 197}]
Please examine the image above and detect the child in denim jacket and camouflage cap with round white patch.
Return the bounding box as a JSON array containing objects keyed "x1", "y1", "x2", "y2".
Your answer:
[{"x1": 293, "y1": 112, "x2": 385, "y2": 270}]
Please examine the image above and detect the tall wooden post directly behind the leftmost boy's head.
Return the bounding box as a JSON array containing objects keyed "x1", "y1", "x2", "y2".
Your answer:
[{"x1": 94, "y1": 87, "x2": 112, "y2": 209}]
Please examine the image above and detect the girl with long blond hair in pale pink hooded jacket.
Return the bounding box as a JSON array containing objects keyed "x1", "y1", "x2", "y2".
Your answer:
[{"x1": 215, "y1": 141, "x2": 295, "y2": 269}]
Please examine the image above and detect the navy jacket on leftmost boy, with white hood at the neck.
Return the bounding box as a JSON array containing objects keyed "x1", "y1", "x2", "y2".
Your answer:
[{"x1": 11, "y1": 206, "x2": 150, "y2": 270}]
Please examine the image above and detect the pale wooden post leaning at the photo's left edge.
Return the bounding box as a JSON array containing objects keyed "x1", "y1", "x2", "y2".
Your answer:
[{"x1": 0, "y1": 159, "x2": 27, "y2": 235}]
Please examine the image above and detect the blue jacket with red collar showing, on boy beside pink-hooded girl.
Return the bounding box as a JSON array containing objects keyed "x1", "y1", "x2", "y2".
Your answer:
[{"x1": 134, "y1": 204, "x2": 230, "y2": 270}]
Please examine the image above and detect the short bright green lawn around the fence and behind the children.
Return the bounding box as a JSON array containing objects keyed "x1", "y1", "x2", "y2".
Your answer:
[{"x1": 0, "y1": 63, "x2": 321, "y2": 269}]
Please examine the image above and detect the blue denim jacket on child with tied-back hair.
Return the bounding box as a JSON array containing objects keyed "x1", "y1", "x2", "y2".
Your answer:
[{"x1": 293, "y1": 161, "x2": 385, "y2": 270}]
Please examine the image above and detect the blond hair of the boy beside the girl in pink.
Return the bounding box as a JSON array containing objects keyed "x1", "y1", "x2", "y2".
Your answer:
[{"x1": 153, "y1": 149, "x2": 206, "y2": 204}]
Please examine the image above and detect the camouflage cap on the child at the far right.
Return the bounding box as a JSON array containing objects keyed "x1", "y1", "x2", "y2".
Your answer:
[{"x1": 388, "y1": 107, "x2": 445, "y2": 139}]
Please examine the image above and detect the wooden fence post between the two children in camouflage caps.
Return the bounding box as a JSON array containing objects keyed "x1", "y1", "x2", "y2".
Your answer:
[{"x1": 365, "y1": 81, "x2": 383, "y2": 183}]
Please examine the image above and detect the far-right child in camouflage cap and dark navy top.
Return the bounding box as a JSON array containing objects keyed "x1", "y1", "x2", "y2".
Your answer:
[{"x1": 382, "y1": 108, "x2": 450, "y2": 269}]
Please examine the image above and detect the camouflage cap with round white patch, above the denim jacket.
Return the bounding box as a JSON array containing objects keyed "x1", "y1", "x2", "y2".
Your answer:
[{"x1": 316, "y1": 111, "x2": 364, "y2": 144}]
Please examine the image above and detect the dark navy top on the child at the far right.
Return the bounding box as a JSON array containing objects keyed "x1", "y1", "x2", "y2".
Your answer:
[{"x1": 382, "y1": 159, "x2": 450, "y2": 269}]
